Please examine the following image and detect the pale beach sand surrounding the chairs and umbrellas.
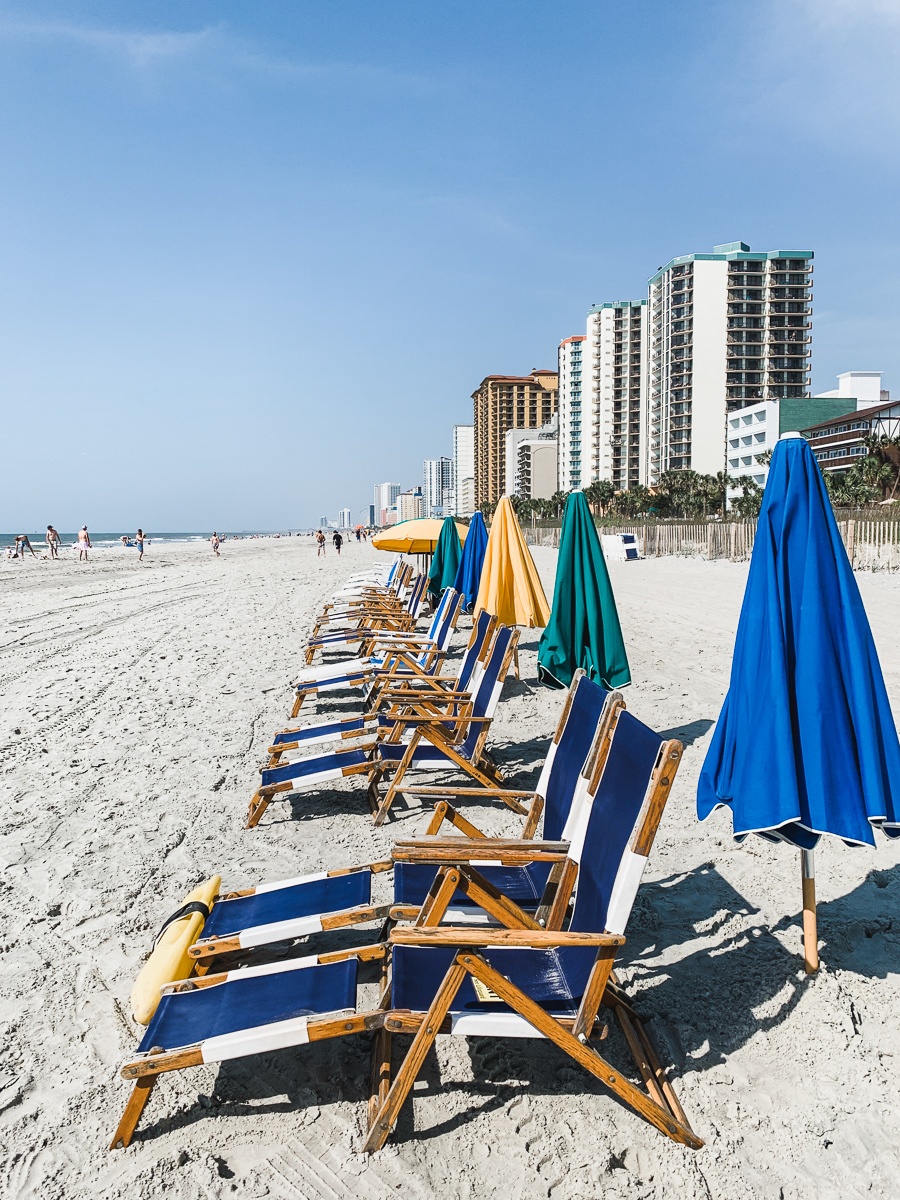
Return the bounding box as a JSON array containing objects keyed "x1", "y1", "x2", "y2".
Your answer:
[{"x1": 0, "y1": 539, "x2": 900, "y2": 1200}]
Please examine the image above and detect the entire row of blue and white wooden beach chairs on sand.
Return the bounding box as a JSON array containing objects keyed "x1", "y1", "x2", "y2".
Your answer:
[{"x1": 112, "y1": 552, "x2": 702, "y2": 1152}]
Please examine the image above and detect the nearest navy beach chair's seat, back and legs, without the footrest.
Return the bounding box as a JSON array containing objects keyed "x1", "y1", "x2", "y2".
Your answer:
[{"x1": 365, "y1": 713, "x2": 702, "y2": 1152}]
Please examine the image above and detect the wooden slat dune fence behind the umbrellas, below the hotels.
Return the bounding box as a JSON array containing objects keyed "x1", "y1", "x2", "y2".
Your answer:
[{"x1": 526, "y1": 518, "x2": 900, "y2": 571}]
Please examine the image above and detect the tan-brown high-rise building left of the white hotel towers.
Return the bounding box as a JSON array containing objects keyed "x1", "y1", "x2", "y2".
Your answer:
[{"x1": 472, "y1": 371, "x2": 559, "y2": 508}]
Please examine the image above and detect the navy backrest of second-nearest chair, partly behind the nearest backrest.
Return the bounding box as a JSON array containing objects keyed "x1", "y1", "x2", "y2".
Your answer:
[{"x1": 535, "y1": 668, "x2": 620, "y2": 841}]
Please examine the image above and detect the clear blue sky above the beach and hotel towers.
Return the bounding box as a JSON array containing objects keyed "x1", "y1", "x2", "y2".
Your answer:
[{"x1": 0, "y1": 0, "x2": 900, "y2": 530}]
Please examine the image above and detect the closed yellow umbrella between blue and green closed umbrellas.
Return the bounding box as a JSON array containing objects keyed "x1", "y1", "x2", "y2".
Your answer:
[{"x1": 474, "y1": 496, "x2": 550, "y2": 629}]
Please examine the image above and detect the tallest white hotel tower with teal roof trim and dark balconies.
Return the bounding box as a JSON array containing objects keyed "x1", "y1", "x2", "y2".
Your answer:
[{"x1": 646, "y1": 241, "x2": 812, "y2": 485}]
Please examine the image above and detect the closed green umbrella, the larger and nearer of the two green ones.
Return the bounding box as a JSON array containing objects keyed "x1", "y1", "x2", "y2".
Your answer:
[{"x1": 538, "y1": 492, "x2": 631, "y2": 688}]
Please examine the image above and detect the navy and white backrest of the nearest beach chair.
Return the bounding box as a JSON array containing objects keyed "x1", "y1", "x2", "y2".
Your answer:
[{"x1": 569, "y1": 712, "x2": 682, "y2": 934}]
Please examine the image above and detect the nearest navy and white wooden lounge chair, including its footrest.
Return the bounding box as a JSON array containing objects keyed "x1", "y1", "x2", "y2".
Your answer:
[{"x1": 110, "y1": 700, "x2": 702, "y2": 1152}]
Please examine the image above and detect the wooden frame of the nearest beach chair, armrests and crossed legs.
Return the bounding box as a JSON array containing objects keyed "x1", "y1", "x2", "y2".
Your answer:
[{"x1": 365, "y1": 724, "x2": 702, "y2": 1153}]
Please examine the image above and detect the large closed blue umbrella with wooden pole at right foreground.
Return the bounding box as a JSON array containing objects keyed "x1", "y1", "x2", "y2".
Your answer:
[{"x1": 697, "y1": 433, "x2": 900, "y2": 971}]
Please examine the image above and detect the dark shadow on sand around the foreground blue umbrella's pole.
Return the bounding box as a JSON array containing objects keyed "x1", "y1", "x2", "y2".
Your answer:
[{"x1": 623, "y1": 866, "x2": 900, "y2": 1072}]
